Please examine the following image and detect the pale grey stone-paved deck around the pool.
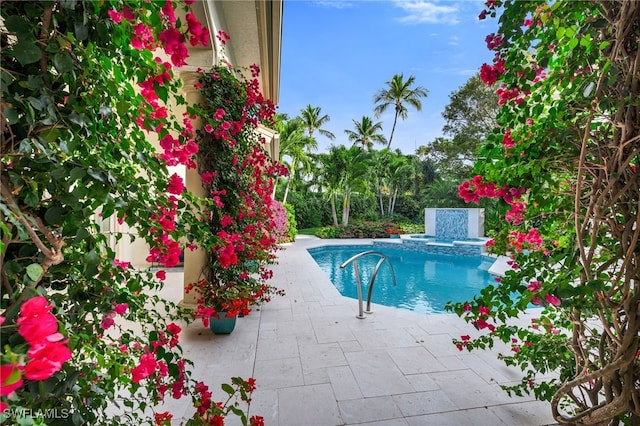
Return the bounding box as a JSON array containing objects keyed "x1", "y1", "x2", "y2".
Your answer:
[{"x1": 159, "y1": 236, "x2": 555, "y2": 426}]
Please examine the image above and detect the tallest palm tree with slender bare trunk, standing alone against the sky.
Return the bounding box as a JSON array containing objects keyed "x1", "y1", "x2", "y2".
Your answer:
[{"x1": 373, "y1": 74, "x2": 429, "y2": 148}]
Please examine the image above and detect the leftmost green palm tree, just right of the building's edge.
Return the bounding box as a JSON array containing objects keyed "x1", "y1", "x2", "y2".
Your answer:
[{"x1": 276, "y1": 117, "x2": 318, "y2": 203}]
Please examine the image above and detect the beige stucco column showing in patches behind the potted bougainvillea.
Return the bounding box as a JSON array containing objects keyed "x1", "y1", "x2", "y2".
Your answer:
[{"x1": 180, "y1": 71, "x2": 207, "y2": 308}]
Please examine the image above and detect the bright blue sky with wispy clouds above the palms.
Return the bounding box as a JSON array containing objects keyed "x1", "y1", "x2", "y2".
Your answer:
[{"x1": 278, "y1": 0, "x2": 497, "y2": 154}]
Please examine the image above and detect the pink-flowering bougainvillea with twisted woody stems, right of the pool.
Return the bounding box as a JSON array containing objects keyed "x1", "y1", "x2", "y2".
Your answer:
[{"x1": 451, "y1": 0, "x2": 640, "y2": 425}]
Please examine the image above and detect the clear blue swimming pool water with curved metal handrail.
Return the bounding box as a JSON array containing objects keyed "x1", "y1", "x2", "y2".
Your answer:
[{"x1": 308, "y1": 246, "x2": 495, "y2": 314}]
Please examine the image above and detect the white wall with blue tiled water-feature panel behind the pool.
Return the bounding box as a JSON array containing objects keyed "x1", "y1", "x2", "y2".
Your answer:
[{"x1": 424, "y1": 208, "x2": 484, "y2": 240}]
